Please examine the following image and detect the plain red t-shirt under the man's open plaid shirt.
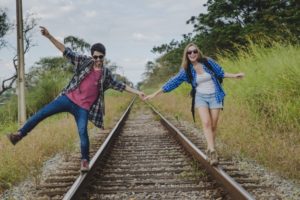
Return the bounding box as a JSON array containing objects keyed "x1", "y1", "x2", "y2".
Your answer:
[{"x1": 67, "y1": 68, "x2": 102, "y2": 110}]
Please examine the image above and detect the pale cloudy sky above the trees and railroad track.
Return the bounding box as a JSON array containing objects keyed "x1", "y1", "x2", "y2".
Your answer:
[{"x1": 0, "y1": 0, "x2": 206, "y2": 84}]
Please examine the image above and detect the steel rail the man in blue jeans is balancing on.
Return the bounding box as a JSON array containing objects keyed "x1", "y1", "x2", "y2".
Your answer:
[{"x1": 63, "y1": 97, "x2": 136, "y2": 200}]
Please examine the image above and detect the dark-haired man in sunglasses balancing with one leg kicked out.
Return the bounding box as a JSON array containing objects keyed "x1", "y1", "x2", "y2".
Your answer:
[{"x1": 8, "y1": 26, "x2": 144, "y2": 172}]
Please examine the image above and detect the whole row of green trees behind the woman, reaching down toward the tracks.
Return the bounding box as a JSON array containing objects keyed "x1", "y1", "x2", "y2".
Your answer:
[{"x1": 143, "y1": 0, "x2": 300, "y2": 85}]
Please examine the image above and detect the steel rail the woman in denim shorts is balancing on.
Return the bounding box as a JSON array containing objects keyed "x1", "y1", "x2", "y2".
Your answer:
[{"x1": 148, "y1": 103, "x2": 255, "y2": 200}]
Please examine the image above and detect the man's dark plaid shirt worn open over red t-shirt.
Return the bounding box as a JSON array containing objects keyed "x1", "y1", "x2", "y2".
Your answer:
[{"x1": 60, "y1": 48, "x2": 126, "y2": 128}]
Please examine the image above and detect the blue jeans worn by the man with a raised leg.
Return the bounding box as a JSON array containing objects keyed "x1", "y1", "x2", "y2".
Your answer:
[{"x1": 19, "y1": 95, "x2": 90, "y2": 160}]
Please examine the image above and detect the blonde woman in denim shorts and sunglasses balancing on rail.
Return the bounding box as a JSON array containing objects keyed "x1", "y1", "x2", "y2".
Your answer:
[{"x1": 144, "y1": 43, "x2": 244, "y2": 165}]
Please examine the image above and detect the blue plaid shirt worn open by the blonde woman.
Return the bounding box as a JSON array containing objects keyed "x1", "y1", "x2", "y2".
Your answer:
[{"x1": 162, "y1": 58, "x2": 225, "y2": 103}]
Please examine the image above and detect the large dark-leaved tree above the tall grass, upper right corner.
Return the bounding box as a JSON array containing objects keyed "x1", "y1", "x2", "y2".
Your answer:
[{"x1": 187, "y1": 0, "x2": 300, "y2": 54}]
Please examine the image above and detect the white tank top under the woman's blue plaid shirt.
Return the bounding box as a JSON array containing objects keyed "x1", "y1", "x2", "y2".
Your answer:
[{"x1": 196, "y1": 72, "x2": 216, "y2": 94}]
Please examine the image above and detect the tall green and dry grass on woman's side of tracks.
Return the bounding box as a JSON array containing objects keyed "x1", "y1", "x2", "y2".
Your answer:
[{"x1": 148, "y1": 43, "x2": 300, "y2": 180}]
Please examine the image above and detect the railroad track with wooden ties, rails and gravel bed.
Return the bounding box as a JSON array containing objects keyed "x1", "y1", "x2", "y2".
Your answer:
[{"x1": 35, "y1": 101, "x2": 277, "y2": 200}]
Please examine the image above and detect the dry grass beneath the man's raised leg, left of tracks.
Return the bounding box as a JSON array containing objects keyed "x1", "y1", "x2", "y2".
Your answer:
[{"x1": 0, "y1": 114, "x2": 76, "y2": 193}]
